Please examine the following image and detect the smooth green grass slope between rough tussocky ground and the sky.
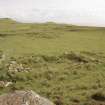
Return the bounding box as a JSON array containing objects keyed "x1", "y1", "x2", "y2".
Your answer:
[{"x1": 0, "y1": 20, "x2": 105, "y2": 56}]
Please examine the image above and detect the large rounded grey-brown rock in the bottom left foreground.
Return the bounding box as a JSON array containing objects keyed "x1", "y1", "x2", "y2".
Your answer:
[{"x1": 0, "y1": 91, "x2": 54, "y2": 105}]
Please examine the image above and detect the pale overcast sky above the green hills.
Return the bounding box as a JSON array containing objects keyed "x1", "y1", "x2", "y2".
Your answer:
[{"x1": 0, "y1": 0, "x2": 105, "y2": 27}]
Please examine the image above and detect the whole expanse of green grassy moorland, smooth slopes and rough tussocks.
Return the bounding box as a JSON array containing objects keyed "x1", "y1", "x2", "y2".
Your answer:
[{"x1": 0, "y1": 19, "x2": 105, "y2": 105}]
